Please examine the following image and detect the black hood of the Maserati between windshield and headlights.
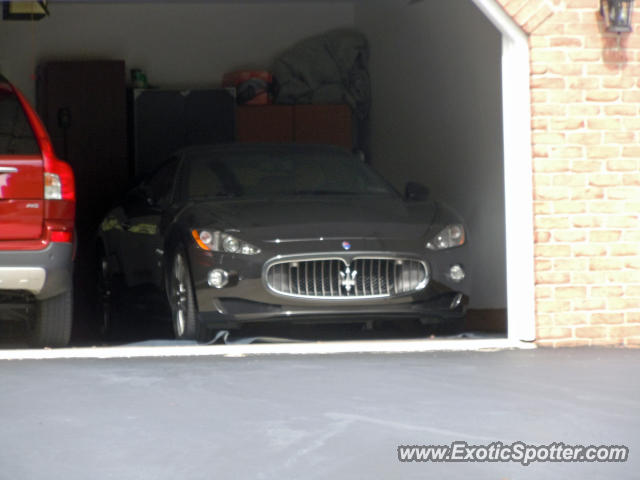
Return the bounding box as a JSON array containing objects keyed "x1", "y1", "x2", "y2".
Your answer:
[{"x1": 183, "y1": 196, "x2": 436, "y2": 241}]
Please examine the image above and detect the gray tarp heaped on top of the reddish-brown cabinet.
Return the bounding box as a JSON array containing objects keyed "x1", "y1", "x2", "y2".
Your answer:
[{"x1": 273, "y1": 30, "x2": 371, "y2": 119}]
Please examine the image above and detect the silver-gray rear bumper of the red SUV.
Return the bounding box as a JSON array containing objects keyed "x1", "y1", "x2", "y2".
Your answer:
[{"x1": 0, "y1": 243, "x2": 73, "y2": 300}]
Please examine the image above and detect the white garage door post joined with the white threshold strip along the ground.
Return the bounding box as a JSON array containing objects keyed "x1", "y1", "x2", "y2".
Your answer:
[{"x1": 0, "y1": 0, "x2": 535, "y2": 360}]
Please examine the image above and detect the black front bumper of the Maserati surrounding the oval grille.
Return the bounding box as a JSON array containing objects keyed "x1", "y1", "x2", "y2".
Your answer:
[{"x1": 188, "y1": 239, "x2": 470, "y2": 327}]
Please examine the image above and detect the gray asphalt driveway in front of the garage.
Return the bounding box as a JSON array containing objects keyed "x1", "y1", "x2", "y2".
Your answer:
[{"x1": 0, "y1": 349, "x2": 640, "y2": 480}]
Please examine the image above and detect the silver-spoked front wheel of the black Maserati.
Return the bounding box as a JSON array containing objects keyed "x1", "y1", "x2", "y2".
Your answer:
[{"x1": 169, "y1": 248, "x2": 202, "y2": 340}]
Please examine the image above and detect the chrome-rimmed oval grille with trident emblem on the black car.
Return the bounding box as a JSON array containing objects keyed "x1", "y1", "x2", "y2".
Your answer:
[{"x1": 265, "y1": 257, "x2": 429, "y2": 300}]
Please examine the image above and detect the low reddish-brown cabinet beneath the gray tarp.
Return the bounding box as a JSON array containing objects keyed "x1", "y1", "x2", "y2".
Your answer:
[{"x1": 236, "y1": 105, "x2": 353, "y2": 150}]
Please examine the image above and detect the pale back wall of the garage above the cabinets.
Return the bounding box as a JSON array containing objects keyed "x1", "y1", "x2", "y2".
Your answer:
[{"x1": 0, "y1": 2, "x2": 354, "y2": 100}]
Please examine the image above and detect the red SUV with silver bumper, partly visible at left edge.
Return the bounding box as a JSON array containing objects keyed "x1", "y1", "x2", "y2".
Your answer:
[{"x1": 0, "y1": 75, "x2": 76, "y2": 347}]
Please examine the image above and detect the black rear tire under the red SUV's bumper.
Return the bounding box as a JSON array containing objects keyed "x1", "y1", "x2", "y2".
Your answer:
[{"x1": 29, "y1": 290, "x2": 73, "y2": 347}]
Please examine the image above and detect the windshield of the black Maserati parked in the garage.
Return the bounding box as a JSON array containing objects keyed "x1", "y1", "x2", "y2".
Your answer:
[{"x1": 182, "y1": 149, "x2": 394, "y2": 198}]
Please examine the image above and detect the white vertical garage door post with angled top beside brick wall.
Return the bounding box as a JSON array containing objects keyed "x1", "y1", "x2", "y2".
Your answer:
[{"x1": 471, "y1": 0, "x2": 535, "y2": 341}]
